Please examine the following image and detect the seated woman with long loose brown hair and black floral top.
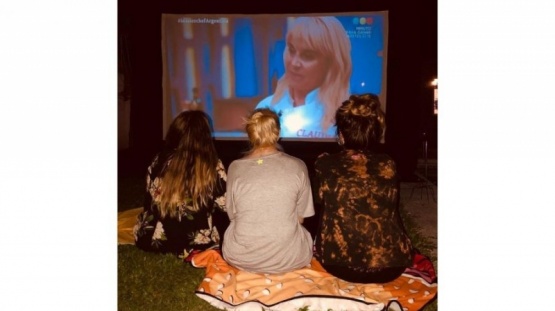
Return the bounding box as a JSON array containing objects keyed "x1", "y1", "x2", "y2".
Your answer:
[{"x1": 133, "y1": 110, "x2": 229, "y2": 258}]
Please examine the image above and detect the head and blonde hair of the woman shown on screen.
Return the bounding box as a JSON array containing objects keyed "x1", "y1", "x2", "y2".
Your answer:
[{"x1": 275, "y1": 16, "x2": 352, "y2": 129}]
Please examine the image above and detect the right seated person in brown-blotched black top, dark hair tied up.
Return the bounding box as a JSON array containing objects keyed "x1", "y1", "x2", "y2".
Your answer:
[{"x1": 314, "y1": 94, "x2": 412, "y2": 283}]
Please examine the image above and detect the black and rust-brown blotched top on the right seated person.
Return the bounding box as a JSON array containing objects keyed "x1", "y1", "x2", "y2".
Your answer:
[{"x1": 314, "y1": 150, "x2": 412, "y2": 269}]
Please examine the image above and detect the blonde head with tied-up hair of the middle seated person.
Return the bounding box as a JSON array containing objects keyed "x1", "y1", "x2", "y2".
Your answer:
[{"x1": 245, "y1": 108, "x2": 281, "y2": 149}]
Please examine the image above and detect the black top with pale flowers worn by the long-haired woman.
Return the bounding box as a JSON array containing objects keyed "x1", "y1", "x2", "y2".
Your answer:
[{"x1": 133, "y1": 155, "x2": 227, "y2": 258}]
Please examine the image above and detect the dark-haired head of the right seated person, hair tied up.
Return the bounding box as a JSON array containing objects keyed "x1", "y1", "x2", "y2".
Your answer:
[{"x1": 335, "y1": 94, "x2": 385, "y2": 150}]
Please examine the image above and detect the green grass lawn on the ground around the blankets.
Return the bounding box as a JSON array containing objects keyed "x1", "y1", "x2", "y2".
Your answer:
[{"x1": 118, "y1": 179, "x2": 437, "y2": 311}]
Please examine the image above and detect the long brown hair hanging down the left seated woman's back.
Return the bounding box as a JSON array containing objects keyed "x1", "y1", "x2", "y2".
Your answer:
[{"x1": 159, "y1": 110, "x2": 218, "y2": 217}]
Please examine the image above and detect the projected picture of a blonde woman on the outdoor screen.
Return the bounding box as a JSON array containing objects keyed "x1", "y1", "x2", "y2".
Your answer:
[{"x1": 162, "y1": 12, "x2": 387, "y2": 141}]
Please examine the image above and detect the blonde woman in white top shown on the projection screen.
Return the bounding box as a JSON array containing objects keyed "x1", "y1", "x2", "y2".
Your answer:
[{"x1": 256, "y1": 16, "x2": 352, "y2": 138}]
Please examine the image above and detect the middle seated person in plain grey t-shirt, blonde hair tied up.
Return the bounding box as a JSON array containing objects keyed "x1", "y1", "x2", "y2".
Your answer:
[{"x1": 222, "y1": 109, "x2": 314, "y2": 273}]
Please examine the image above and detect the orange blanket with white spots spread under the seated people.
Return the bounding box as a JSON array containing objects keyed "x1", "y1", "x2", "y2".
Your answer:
[{"x1": 191, "y1": 250, "x2": 437, "y2": 311}]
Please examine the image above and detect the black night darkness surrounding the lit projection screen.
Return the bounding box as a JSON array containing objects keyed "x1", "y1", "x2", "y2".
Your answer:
[{"x1": 118, "y1": 0, "x2": 437, "y2": 181}]
